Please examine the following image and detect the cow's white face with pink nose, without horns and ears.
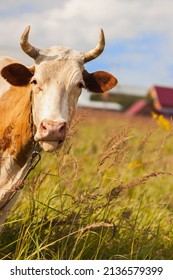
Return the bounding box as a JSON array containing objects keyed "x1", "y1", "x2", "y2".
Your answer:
[{"x1": 31, "y1": 49, "x2": 84, "y2": 151}]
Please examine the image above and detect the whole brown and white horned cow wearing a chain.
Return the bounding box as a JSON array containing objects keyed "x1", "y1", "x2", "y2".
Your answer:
[{"x1": 0, "y1": 26, "x2": 117, "y2": 232}]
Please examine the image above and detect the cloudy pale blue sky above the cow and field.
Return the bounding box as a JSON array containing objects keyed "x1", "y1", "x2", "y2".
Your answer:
[{"x1": 0, "y1": 0, "x2": 173, "y2": 87}]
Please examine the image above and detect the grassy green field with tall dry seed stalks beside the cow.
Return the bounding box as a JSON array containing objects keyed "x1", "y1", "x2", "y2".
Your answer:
[{"x1": 0, "y1": 111, "x2": 173, "y2": 260}]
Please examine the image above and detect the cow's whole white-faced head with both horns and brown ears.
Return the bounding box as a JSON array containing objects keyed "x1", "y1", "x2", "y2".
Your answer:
[{"x1": 1, "y1": 26, "x2": 117, "y2": 152}]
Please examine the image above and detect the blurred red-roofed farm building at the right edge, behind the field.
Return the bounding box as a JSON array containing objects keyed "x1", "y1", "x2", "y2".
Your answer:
[{"x1": 148, "y1": 86, "x2": 173, "y2": 116}]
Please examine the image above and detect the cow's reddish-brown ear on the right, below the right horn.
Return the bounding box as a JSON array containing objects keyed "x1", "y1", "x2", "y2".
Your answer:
[{"x1": 83, "y1": 70, "x2": 118, "y2": 93}]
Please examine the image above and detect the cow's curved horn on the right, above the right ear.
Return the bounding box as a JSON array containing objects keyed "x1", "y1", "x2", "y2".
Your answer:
[{"x1": 83, "y1": 29, "x2": 105, "y2": 62}]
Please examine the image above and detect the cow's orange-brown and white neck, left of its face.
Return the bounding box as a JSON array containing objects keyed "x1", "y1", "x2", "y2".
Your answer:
[{"x1": 0, "y1": 87, "x2": 32, "y2": 192}]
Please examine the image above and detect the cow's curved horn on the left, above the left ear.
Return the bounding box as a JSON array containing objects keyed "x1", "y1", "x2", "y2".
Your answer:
[{"x1": 20, "y1": 26, "x2": 40, "y2": 59}]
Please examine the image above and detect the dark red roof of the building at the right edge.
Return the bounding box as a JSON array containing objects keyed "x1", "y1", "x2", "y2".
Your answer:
[{"x1": 154, "y1": 86, "x2": 173, "y2": 107}]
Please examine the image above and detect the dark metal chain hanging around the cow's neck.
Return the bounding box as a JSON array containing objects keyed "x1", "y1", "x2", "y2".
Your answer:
[{"x1": 0, "y1": 91, "x2": 41, "y2": 211}]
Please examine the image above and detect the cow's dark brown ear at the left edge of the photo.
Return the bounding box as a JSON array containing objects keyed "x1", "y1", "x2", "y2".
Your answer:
[{"x1": 1, "y1": 63, "x2": 34, "y2": 86}]
